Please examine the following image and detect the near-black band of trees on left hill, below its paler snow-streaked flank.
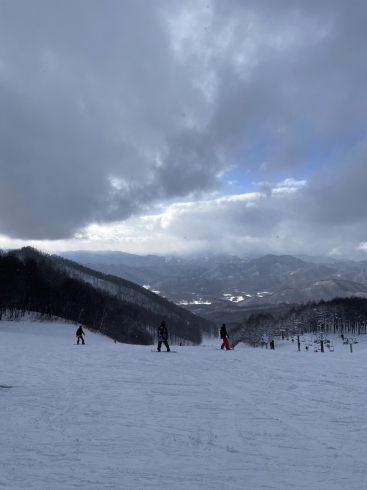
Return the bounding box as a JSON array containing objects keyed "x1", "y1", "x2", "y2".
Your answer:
[{"x1": 0, "y1": 247, "x2": 207, "y2": 345}]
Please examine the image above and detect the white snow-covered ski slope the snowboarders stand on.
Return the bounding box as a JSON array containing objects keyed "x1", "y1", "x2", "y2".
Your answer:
[{"x1": 0, "y1": 321, "x2": 367, "y2": 490}]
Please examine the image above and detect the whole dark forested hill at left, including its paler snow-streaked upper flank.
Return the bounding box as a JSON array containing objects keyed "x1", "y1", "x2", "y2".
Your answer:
[{"x1": 0, "y1": 247, "x2": 216, "y2": 344}]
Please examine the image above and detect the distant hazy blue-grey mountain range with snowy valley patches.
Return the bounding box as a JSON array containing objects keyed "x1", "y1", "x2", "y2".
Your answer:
[{"x1": 59, "y1": 251, "x2": 367, "y2": 320}]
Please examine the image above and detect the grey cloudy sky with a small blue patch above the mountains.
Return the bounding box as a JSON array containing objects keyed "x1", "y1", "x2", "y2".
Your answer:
[{"x1": 0, "y1": 0, "x2": 367, "y2": 259}]
